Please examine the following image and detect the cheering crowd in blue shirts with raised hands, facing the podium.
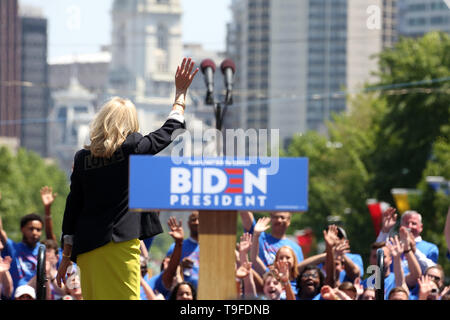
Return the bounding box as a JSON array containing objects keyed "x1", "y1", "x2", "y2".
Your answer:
[{"x1": 0, "y1": 186, "x2": 450, "y2": 300}]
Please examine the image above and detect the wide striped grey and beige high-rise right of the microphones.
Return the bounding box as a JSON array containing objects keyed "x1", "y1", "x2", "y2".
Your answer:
[{"x1": 227, "y1": 0, "x2": 396, "y2": 145}]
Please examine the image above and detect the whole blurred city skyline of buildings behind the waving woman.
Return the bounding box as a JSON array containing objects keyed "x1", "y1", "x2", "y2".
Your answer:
[{"x1": 0, "y1": 0, "x2": 450, "y2": 169}]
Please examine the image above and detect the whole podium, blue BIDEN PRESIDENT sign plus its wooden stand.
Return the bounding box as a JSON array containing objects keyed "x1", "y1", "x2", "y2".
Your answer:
[{"x1": 128, "y1": 155, "x2": 308, "y2": 300}]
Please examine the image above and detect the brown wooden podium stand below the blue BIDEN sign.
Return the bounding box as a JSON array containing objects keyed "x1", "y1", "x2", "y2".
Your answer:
[{"x1": 197, "y1": 211, "x2": 237, "y2": 300}]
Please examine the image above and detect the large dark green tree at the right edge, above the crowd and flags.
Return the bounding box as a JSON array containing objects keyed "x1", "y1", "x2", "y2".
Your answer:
[{"x1": 368, "y1": 32, "x2": 450, "y2": 202}]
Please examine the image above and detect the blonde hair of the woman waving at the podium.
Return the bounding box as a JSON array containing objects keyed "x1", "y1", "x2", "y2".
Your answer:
[{"x1": 85, "y1": 97, "x2": 139, "y2": 158}]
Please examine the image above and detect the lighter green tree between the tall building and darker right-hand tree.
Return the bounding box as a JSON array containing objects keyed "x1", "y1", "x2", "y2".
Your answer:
[{"x1": 286, "y1": 94, "x2": 386, "y2": 257}]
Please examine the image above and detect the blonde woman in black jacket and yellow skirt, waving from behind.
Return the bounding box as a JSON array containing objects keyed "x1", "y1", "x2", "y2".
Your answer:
[{"x1": 57, "y1": 58, "x2": 198, "y2": 300}]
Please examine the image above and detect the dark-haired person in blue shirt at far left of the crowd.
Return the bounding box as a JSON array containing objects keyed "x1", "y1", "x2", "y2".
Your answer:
[{"x1": 0, "y1": 213, "x2": 43, "y2": 290}]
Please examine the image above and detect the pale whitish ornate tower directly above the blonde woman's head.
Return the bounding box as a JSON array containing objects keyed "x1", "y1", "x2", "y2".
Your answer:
[{"x1": 109, "y1": 0, "x2": 183, "y2": 110}]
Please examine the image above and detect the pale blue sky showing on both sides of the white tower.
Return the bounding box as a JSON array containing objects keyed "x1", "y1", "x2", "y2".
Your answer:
[{"x1": 19, "y1": 0, "x2": 231, "y2": 60}]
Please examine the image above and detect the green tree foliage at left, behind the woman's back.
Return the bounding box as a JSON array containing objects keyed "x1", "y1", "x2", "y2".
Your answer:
[{"x1": 0, "y1": 147, "x2": 69, "y2": 241}]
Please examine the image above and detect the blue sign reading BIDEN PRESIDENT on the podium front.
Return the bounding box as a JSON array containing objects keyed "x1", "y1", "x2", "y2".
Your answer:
[{"x1": 129, "y1": 155, "x2": 308, "y2": 211}]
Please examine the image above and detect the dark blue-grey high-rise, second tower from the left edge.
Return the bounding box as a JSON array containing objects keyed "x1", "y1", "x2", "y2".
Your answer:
[{"x1": 20, "y1": 6, "x2": 50, "y2": 157}]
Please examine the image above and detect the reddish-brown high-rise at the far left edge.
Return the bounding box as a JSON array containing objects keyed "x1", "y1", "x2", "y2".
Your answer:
[{"x1": 0, "y1": 0, "x2": 21, "y2": 139}]
